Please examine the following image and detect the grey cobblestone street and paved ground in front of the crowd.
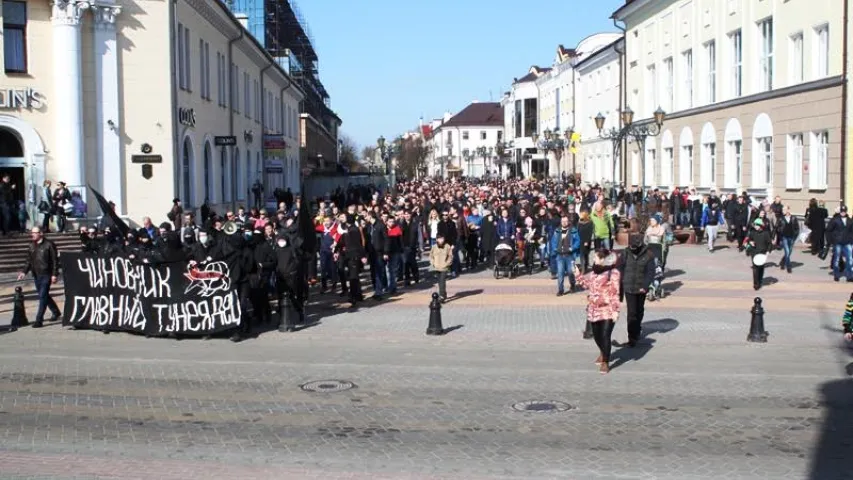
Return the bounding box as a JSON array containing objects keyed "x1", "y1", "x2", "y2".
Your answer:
[{"x1": 0, "y1": 246, "x2": 853, "y2": 480}]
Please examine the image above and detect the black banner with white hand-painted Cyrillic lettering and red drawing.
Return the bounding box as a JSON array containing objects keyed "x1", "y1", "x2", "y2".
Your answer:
[{"x1": 60, "y1": 252, "x2": 242, "y2": 336}]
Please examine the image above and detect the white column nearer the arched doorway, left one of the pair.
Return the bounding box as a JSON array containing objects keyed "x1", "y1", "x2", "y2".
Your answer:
[{"x1": 51, "y1": 0, "x2": 90, "y2": 187}]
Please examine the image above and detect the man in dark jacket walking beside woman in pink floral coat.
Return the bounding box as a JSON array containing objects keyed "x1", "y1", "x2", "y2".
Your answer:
[{"x1": 622, "y1": 233, "x2": 657, "y2": 347}]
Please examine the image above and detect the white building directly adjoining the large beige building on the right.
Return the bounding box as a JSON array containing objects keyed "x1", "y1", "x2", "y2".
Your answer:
[{"x1": 574, "y1": 35, "x2": 625, "y2": 183}]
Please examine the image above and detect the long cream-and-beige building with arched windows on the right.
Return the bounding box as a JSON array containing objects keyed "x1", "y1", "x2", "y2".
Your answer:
[{"x1": 613, "y1": 0, "x2": 843, "y2": 213}]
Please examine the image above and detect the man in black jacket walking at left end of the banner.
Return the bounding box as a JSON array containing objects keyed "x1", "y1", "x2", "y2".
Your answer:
[{"x1": 18, "y1": 227, "x2": 60, "y2": 328}]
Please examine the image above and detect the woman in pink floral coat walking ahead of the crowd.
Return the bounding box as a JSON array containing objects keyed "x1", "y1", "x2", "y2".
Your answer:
[{"x1": 575, "y1": 249, "x2": 621, "y2": 375}]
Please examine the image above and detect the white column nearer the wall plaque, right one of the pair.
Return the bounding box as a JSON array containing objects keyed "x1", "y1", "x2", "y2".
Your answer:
[{"x1": 92, "y1": 5, "x2": 125, "y2": 214}]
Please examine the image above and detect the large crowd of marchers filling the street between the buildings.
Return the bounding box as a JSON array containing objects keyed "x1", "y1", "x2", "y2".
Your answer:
[{"x1": 15, "y1": 176, "x2": 853, "y2": 373}]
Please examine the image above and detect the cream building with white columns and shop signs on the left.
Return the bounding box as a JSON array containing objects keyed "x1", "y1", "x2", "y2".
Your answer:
[{"x1": 0, "y1": 0, "x2": 303, "y2": 226}]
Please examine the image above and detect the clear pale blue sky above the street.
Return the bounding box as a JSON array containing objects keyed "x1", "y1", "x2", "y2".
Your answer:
[{"x1": 292, "y1": 0, "x2": 624, "y2": 151}]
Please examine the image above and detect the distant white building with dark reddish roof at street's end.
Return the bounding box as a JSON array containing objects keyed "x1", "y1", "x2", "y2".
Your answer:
[{"x1": 430, "y1": 102, "x2": 504, "y2": 178}]
